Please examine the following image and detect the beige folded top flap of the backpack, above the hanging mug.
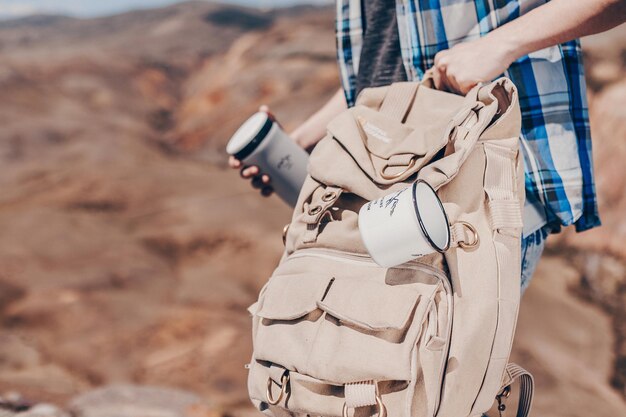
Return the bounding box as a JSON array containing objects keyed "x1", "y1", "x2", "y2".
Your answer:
[{"x1": 309, "y1": 82, "x2": 464, "y2": 192}]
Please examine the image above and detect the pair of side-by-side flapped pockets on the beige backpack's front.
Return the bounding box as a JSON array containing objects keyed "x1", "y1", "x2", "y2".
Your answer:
[{"x1": 255, "y1": 250, "x2": 441, "y2": 383}]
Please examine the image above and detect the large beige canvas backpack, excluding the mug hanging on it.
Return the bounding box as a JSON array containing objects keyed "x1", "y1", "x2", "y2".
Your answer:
[{"x1": 247, "y1": 78, "x2": 533, "y2": 417}]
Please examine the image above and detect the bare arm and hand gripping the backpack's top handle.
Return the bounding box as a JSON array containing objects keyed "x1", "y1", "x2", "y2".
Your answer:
[{"x1": 433, "y1": 0, "x2": 626, "y2": 94}]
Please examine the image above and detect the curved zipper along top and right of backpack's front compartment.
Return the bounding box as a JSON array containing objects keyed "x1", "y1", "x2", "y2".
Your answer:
[{"x1": 285, "y1": 248, "x2": 454, "y2": 415}]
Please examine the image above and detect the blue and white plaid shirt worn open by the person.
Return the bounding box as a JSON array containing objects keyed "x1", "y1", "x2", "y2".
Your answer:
[{"x1": 336, "y1": 0, "x2": 600, "y2": 232}]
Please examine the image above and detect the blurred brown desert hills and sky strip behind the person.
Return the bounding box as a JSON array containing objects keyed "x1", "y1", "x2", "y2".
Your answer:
[{"x1": 0, "y1": 0, "x2": 626, "y2": 417}]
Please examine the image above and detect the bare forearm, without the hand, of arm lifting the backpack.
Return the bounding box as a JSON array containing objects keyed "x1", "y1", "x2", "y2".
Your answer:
[{"x1": 486, "y1": 0, "x2": 626, "y2": 61}]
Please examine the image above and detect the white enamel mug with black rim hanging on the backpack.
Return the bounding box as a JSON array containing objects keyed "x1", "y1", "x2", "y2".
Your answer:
[{"x1": 359, "y1": 180, "x2": 450, "y2": 267}]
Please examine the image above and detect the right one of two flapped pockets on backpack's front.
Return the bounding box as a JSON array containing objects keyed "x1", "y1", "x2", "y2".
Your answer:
[{"x1": 307, "y1": 277, "x2": 429, "y2": 383}]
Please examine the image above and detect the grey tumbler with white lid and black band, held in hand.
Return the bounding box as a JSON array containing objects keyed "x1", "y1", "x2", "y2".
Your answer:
[{"x1": 226, "y1": 112, "x2": 309, "y2": 207}]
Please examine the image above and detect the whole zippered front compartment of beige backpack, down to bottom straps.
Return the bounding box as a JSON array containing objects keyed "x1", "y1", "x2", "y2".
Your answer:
[{"x1": 250, "y1": 249, "x2": 452, "y2": 416}]
